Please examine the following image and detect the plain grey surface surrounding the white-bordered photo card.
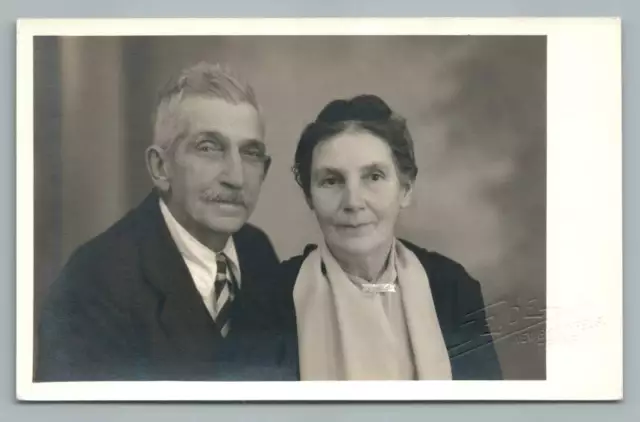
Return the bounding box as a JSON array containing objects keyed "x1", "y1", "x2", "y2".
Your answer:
[{"x1": 0, "y1": 0, "x2": 640, "y2": 421}]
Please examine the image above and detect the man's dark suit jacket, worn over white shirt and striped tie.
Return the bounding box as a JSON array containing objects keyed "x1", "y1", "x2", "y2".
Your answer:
[{"x1": 35, "y1": 193, "x2": 281, "y2": 381}]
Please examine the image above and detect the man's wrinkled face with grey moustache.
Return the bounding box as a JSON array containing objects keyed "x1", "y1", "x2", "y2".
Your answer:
[{"x1": 165, "y1": 96, "x2": 268, "y2": 239}]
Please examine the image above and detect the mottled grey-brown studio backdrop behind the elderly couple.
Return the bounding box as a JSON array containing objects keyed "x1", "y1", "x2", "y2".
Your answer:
[{"x1": 34, "y1": 36, "x2": 546, "y2": 379}]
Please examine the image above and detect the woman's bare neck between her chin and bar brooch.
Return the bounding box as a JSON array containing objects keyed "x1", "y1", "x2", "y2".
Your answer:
[{"x1": 327, "y1": 239, "x2": 393, "y2": 282}]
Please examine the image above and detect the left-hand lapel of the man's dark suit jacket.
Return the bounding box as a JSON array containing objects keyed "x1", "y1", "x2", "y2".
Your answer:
[{"x1": 137, "y1": 193, "x2": 221, "y2": 358}]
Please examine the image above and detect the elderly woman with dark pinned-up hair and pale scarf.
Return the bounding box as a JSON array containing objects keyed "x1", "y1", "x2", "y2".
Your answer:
[{"x1": 282, "y1": 95, "x2": 501, "y2": 380}]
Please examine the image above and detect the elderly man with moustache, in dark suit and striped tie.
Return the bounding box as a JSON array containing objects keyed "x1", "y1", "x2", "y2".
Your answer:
[{"x1": 36, "y1": 63, "x2": 282, "y2": 381}]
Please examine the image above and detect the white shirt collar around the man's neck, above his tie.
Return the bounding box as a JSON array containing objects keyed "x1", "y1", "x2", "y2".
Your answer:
[{"x1": 160, "y1": 198, "x2": 240, "y2": 280}]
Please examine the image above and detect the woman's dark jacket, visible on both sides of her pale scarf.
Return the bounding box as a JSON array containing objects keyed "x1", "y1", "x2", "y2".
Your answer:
[{"x1": 280, "y1": 240, "x2": 502, "y2": 380}]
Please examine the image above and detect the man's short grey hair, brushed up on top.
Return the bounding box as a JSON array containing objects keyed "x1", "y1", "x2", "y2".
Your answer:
[{"x1": 153, "y1": 62, "x2": 262, "y2": 149}]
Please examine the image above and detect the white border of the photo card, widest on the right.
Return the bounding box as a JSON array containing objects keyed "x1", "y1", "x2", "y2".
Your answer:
[{"x1": 16, "y1": 18, "x2": 623, "y2": 402}]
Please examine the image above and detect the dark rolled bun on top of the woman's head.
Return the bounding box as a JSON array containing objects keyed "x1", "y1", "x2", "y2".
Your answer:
[{"x1": 316, "y1": 94, "x2": 392, "y2": 123}]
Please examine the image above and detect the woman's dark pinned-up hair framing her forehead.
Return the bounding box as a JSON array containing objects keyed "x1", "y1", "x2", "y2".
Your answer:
[{"x1": 292, "y1": 95, "x2": 418, "y2": 198}]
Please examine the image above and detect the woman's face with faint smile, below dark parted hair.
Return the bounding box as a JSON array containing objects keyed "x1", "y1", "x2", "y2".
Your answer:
[{"x1": 310, "y1": 131, "x2": 411, "y2": 255}]
